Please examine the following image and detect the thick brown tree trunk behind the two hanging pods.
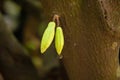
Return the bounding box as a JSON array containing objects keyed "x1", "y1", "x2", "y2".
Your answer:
[{"x1": 40, "y1": 0, "x2": 120, "y2": 80}]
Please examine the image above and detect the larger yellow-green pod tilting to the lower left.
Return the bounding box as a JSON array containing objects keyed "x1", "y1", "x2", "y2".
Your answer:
[{"x1": 41, "y1": 22, "x2": 55, "y2": 53}]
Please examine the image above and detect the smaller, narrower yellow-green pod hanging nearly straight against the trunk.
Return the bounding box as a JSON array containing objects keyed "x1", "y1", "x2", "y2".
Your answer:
[{"x1": 55, "y1": 27, "x2": 64, "y2": 55}]
